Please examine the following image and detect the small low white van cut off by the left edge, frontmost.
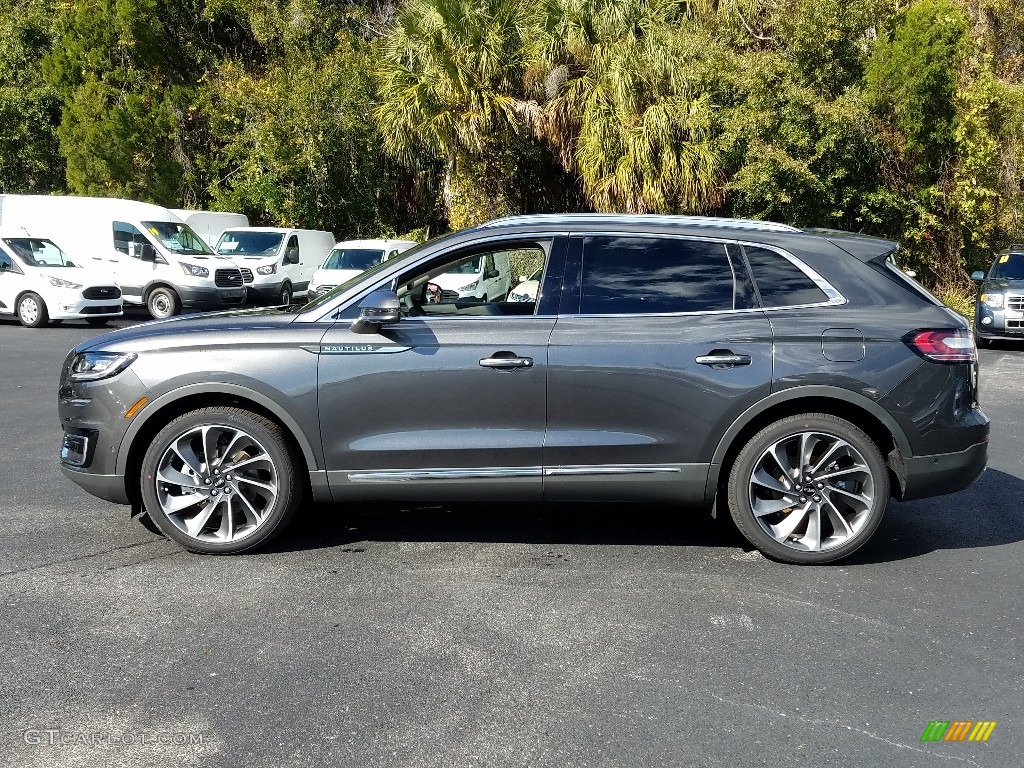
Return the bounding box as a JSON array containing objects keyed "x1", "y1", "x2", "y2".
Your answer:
[{"x1": 0, "y1": 230, "x2": 121, "y2": 328}]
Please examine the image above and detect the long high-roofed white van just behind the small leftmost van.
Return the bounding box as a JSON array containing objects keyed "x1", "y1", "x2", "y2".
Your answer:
[{"x1": 0, "y1": 195, "x2": 246, "y2": 318}]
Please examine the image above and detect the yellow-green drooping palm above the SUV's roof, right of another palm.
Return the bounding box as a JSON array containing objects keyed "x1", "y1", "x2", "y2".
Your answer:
[{"x1": 524, "y1": 0, "x2": 723, "y2": 213}]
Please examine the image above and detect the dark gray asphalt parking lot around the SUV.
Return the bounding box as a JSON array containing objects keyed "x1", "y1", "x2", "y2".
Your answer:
[{"x1": 0, "y1": 319, "x2": 1024, "y2": 768}]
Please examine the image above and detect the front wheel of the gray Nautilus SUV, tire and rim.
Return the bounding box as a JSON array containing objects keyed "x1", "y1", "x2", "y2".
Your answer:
[{"x1": 141, "y1": 408, "x2": 304, "y2": 554}]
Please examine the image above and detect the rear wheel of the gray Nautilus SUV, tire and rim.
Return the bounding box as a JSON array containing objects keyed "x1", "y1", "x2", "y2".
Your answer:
[{"x1": 728, "y1": 414, "x2": 889, "y2": 564}]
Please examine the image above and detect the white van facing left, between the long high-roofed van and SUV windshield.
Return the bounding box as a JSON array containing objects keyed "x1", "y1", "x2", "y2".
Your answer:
[{"x1": 215, "y1": 226, "x2": 334, "y2": 304}]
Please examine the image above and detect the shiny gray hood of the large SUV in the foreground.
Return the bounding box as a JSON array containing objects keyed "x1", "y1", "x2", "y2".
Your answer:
[{"x1": 74, "y1": 308, "x2": 296, "y2": 352}]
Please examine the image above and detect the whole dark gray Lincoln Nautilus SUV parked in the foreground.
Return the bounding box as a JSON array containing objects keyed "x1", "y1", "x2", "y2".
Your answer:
[{"x1": 59, "y1": 214, "x2": 988, "y2": 563}]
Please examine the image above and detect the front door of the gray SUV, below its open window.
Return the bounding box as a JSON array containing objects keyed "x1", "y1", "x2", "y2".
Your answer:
[{"x1": 315, "y1": 236, "x2": 565, "y2": 500}]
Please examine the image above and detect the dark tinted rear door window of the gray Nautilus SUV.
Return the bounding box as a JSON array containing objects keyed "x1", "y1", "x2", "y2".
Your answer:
[{"x1": 580, "y1": 236, "x2": 735, "y2": 314}]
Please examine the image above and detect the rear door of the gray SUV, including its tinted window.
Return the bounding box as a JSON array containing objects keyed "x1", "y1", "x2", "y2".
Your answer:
[{"x1": 544, "y1": 233, "x2": 772, "y2": 504}]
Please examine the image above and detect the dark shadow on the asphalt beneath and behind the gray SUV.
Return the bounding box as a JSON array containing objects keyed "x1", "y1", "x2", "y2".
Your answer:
[{"x1": 266, "y1": 470, "x2": 1024, "y2": 564}]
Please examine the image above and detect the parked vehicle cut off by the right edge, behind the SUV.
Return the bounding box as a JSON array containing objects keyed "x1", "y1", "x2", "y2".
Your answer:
[{"x1": 971, "y1": 245, "x2": 1024, "y2": 347}]
